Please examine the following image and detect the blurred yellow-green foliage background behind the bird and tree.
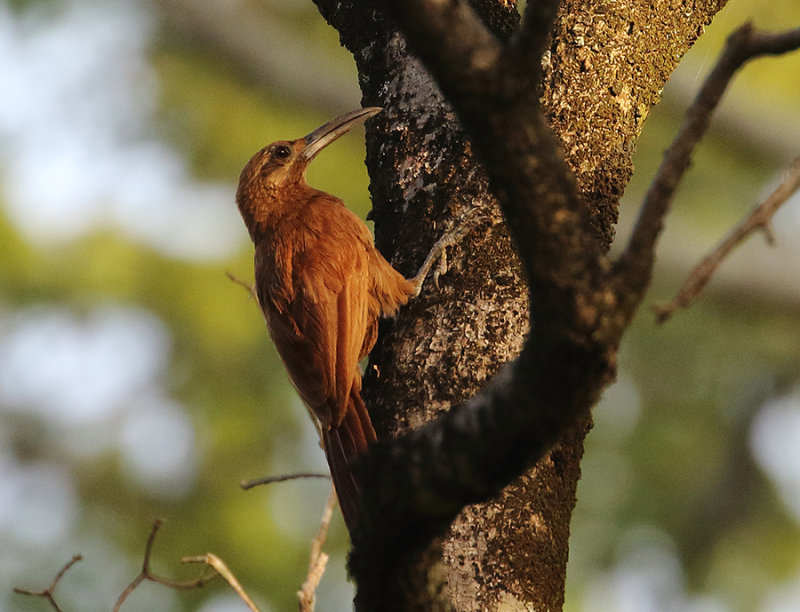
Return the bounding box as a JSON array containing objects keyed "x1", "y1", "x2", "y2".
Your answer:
[{"x1": 0, "y1": 0, "x2": 800, "y2": 611}]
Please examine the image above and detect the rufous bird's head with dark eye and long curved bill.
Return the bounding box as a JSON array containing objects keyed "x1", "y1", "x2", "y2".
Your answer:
[{"x1": 236, "y1": 106, "x2": 382, "y2": 236}]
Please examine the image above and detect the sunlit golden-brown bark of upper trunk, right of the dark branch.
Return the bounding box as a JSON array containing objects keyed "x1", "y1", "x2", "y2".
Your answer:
[{"x1": 542, "y1": 0, "x2": 727, "y2": 249}]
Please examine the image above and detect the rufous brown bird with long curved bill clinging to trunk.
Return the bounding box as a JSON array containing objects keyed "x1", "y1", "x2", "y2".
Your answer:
[{"x1": 236, "y1": 107, "x2": 457, "y2": 529}]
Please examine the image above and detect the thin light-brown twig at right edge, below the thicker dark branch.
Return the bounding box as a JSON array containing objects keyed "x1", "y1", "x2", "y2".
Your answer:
[{"x1": 654, "y1": 157, "x2": 800, "y2": 323}]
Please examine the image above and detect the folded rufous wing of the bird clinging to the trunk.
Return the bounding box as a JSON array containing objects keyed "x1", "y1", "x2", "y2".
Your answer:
[{"x1": 257, "y1": 197, "x2": 372, "y2": 426}]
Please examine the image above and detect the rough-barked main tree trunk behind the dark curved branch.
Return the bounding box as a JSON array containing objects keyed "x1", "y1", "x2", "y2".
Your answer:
[{"x1": 316, "y1": 0, "x2": 724, "y2": 610}]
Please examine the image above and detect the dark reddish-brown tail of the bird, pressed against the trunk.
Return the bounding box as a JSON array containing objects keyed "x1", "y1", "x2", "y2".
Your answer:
[{"x1": 322, "y1": 385, "x2": 376, "y2": 531}]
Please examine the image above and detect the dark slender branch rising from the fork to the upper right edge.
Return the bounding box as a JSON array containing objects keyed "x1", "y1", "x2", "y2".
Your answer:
[{"x1": 617, "y1": 23, "x2": 800, "y2": 310}]
